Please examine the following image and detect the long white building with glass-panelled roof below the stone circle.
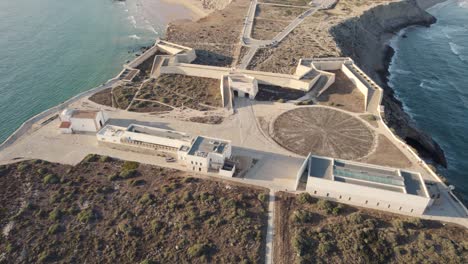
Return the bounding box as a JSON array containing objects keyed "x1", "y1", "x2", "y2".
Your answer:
[{"x1": 297, "y1": 155, "x2": 433, "y2": 215}]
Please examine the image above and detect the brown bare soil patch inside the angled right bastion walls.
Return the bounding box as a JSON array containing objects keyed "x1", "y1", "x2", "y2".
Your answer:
[{"x1": 317, "y1": 70, "x2": 366, "y2": 113}]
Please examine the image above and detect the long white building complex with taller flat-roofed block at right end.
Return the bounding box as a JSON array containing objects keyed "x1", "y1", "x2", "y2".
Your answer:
[{"x1": 96, "y1": 125, "x2": 235, "y2": 177}]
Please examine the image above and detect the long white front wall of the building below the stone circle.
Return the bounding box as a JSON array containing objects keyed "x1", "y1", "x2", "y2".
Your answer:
[{"x1": 306, "y1": 177, "x2": 431, "y2": 215}]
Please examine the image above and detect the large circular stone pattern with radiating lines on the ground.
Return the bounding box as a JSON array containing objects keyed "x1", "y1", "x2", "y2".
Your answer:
[{"x1": 273, "y1": 107, "x2": 374, "y2": 160}]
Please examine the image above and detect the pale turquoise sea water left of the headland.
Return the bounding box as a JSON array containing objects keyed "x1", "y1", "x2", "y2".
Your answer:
[{"x1": 0, "y1": 0, "x2": 157, "y2": 142}]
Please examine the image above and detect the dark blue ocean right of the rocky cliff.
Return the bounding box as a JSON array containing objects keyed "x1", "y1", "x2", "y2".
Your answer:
[{"x1": 389, "y1": 0, "x2": 468, "y2": 200}]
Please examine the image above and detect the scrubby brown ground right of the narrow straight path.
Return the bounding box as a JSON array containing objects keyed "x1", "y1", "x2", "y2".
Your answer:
[{"x1": 273, "y1": 192, "x2": 468, "y2": 264}]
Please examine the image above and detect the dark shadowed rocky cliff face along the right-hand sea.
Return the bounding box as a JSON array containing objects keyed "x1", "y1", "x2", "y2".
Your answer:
[{"x1": 331, "y1": 0, "x2": 447, "y2": 166}]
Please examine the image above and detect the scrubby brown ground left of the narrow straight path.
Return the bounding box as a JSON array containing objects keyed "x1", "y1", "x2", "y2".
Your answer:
[{"x1": 0, "y1": 155, "x2": 268, "y2": 263}]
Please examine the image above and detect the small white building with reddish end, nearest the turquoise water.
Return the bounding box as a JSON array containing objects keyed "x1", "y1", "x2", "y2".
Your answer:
[{"x1": 59, "y1": 109, "x2": 108, "y2": 134}]
